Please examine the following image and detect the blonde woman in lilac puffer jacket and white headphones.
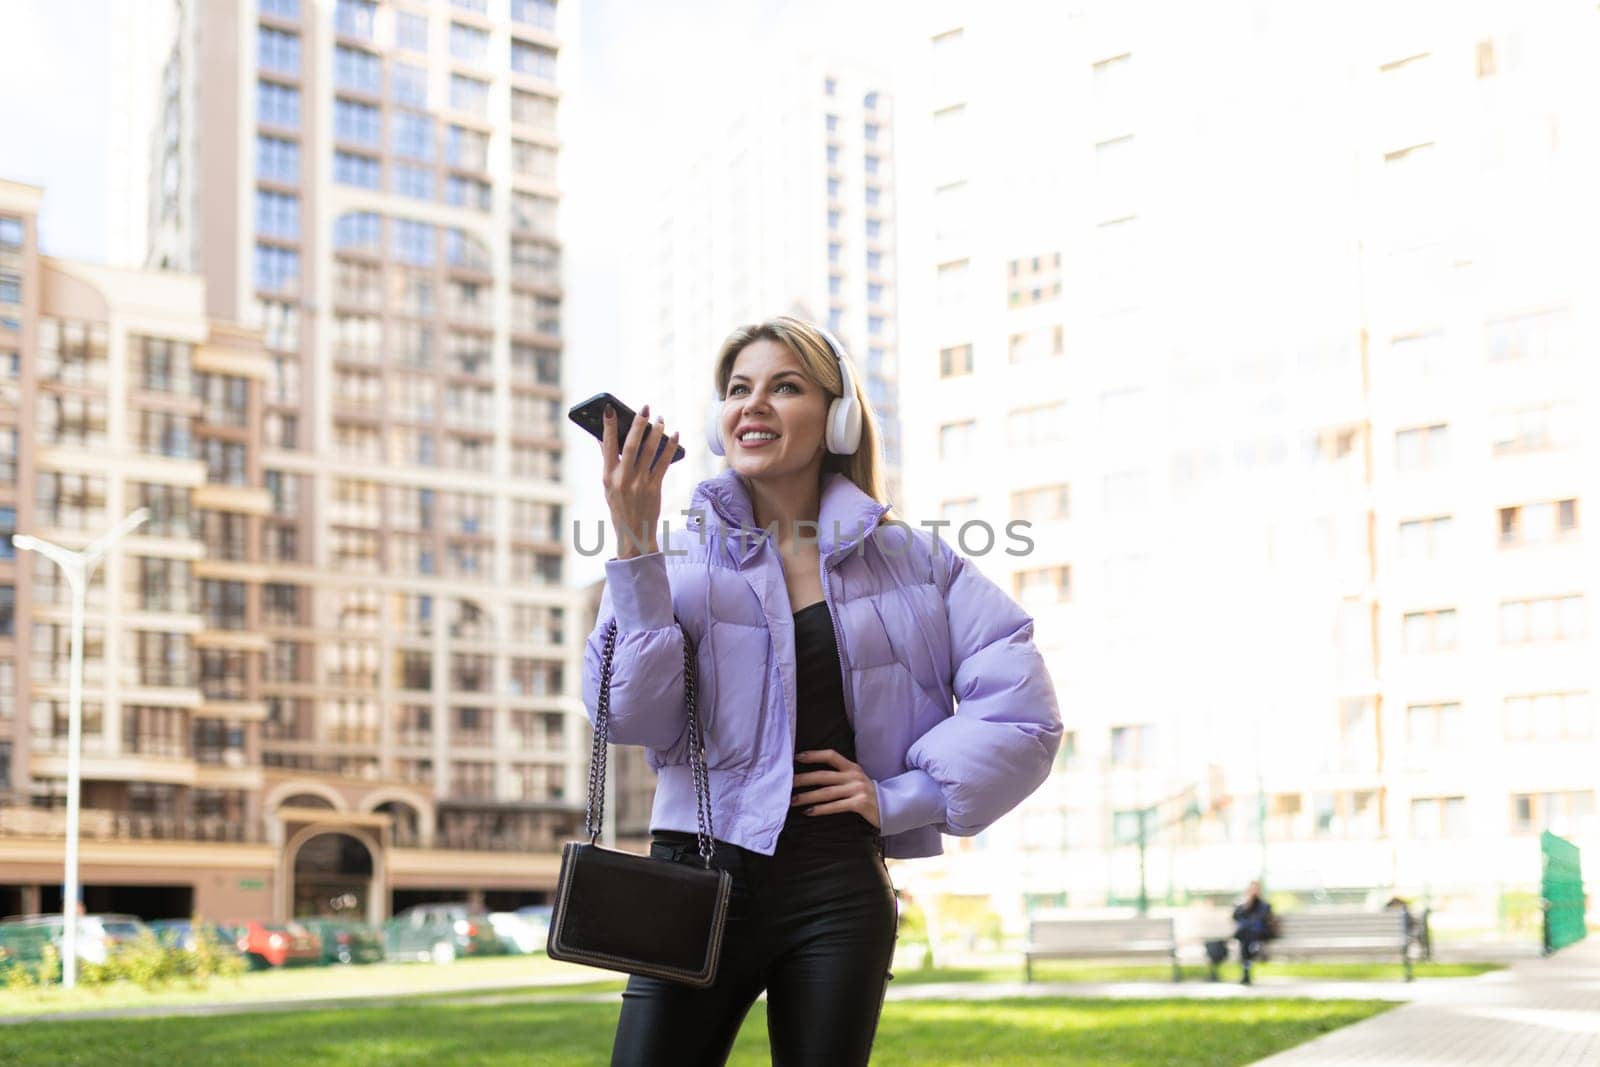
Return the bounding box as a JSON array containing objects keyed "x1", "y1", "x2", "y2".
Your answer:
[{"x1": 584, "y1": 317, "x2": 1061, "y2": 1067}]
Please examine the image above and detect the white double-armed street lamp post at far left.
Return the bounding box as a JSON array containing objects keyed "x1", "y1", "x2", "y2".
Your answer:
[{"x1": 11, "y1": 507, "x2": 150, "y2": 989}]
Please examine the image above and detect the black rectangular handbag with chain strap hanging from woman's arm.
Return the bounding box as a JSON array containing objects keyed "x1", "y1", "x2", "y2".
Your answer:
[{"x1": 546, "y1": 621, "x2": 733, "y2": 989}]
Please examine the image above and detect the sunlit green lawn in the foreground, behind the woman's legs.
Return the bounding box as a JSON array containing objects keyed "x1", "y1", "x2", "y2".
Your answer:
[{"x1": 0, "y1": 998, "x2": 1390, "y2": 1067}]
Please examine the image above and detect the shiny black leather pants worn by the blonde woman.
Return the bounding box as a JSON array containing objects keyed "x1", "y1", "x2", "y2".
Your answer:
[{"x1": 611, "y1": 830, "x2": 898, "y2": 1067}]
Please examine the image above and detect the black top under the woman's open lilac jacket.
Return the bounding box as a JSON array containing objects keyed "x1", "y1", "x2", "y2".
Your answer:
[{"x1": 784, "y1": 600, "x2": 877, "y2": 837}]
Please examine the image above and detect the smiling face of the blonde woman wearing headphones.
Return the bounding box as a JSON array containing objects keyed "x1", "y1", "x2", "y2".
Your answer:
[{"x1": 720, "y1": 338, "x2": 832, "y2": 478}]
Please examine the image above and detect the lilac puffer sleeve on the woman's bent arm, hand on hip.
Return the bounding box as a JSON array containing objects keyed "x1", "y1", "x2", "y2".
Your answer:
[{"x1": 877, "y1": 547, "x2": 1061, "y2": 837}]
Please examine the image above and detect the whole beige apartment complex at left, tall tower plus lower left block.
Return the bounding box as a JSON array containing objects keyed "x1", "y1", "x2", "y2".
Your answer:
[{"x1": 0, "y1": 0, "x2": 587, "y2": 918}]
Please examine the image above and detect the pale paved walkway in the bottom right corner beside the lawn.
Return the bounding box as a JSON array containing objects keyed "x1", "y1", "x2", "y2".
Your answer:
[{"x1": 1256, "y1": 936, "x2": 1600, "y2": 1067}]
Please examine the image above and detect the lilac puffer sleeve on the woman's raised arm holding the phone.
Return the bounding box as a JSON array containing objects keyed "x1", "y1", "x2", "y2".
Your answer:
[{"x1": 584, "y1": 550, "x2": 688, "y2": 755}]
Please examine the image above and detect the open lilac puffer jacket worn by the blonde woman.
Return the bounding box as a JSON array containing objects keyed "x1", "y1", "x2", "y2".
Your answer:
[{"x1": 584, "y1": 469, "x2": 1061, "y2": 859}]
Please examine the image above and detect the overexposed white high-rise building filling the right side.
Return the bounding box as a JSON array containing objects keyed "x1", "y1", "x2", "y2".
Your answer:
[{"x1": 899, "y1": 3, "x2": 1600, "y2": 925}]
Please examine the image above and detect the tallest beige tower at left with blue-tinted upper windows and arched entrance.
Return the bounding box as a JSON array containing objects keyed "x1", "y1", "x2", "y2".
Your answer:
[{"x1": 1, "y1": 0, "x2": 587, "y2": 917}]
